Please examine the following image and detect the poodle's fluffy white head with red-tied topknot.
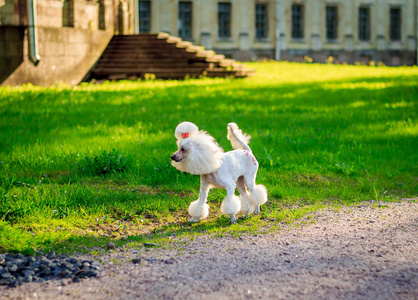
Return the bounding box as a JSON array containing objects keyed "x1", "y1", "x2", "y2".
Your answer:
[{"x1": 171, "y1": 122, "x2": 223, "y2": 175}]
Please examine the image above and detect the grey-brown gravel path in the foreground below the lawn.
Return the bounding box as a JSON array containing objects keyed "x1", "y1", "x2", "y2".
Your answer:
[{"x1": 0, "y1": 198, "x2": 418, "y2": 300}]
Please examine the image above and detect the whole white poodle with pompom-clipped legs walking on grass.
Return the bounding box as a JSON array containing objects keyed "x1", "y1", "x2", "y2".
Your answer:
[{"x1": 171, "y1": 122, "x2": 267, "y2": 223}]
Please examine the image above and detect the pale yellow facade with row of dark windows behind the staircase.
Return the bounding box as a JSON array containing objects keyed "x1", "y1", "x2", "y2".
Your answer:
[{"x1": 132, "y1": 0, "x2": 418, "y2": 66}]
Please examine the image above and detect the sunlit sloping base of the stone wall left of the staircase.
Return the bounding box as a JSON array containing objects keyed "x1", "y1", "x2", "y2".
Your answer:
[{"x1": 0, "y1": 27, "x2": 112, "y2": 85}]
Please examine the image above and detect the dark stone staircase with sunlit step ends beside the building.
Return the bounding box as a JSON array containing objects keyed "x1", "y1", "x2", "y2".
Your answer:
[{"x1": 86, "y1": 33, "x2": 254, "y2": 81}]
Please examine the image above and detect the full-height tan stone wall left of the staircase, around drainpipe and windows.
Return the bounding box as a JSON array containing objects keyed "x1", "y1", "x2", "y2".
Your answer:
[{"x1": 0, "y1": 0, "x2": 115, "y2": 85}]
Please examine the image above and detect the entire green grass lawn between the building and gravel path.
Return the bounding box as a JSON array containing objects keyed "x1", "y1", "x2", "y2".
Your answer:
[{"x1": 0, "y1": 62, "x2": 418, "y2": 253}]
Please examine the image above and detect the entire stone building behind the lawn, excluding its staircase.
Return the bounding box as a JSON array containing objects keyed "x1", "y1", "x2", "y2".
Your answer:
[{"x1": 0, "y1": 0, "x2": 418, "y2": 85}]
